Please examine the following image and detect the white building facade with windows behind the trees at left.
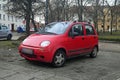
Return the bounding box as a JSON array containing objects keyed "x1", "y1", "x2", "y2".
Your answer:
[{"x1": 0, "y1": 0, "x2": 24, "y2": 31}]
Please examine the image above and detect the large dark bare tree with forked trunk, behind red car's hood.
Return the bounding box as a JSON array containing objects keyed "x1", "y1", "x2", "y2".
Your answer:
[{"x1": 6, "y1": 0, "x2": 44, "y2": 36}]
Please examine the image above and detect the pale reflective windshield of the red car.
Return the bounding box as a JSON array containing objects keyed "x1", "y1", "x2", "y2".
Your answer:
[{"x1": 40, "y1": 22, "x2": 70, "y2": 34}]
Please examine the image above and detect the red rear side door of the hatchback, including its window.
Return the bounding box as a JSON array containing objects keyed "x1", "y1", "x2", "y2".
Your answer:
[{"x1": 85, "y1": 24, "x2": 98, "y2": 52}]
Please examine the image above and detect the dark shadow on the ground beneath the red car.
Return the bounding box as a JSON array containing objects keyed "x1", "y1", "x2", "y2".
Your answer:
[{"x1": 26, "y1": 55, "x2": 91, "y2": 69}]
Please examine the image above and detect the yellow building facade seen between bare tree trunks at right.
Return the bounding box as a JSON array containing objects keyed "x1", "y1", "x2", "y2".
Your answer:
[{"x1": 98, "y1": 6, "x2": 120, "y2": 32}]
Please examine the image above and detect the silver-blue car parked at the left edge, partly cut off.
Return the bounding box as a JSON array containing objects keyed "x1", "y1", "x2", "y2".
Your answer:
[{"x1": 0, "y1": 25, "x2": 12, "y2": 40}]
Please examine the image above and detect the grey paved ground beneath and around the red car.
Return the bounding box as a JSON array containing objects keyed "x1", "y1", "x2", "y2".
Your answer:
[{"x1": 0, "y1": 42, "x2": 120, "y2": 80}]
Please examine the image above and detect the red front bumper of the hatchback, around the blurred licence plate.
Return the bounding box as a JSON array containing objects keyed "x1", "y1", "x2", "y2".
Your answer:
[{"x1": 19, "y1": 45, "x2": 54, "y2": 63}]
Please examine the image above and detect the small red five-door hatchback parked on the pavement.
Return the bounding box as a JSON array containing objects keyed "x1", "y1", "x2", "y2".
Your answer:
[{"x1": 19, "y1": 22, "x2": 99, "y2": 67}]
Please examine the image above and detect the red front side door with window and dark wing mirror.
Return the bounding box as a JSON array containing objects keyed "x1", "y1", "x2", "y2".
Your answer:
[{"x1": 67, "y1": 24, "x2": 86, "y2": 56}]
